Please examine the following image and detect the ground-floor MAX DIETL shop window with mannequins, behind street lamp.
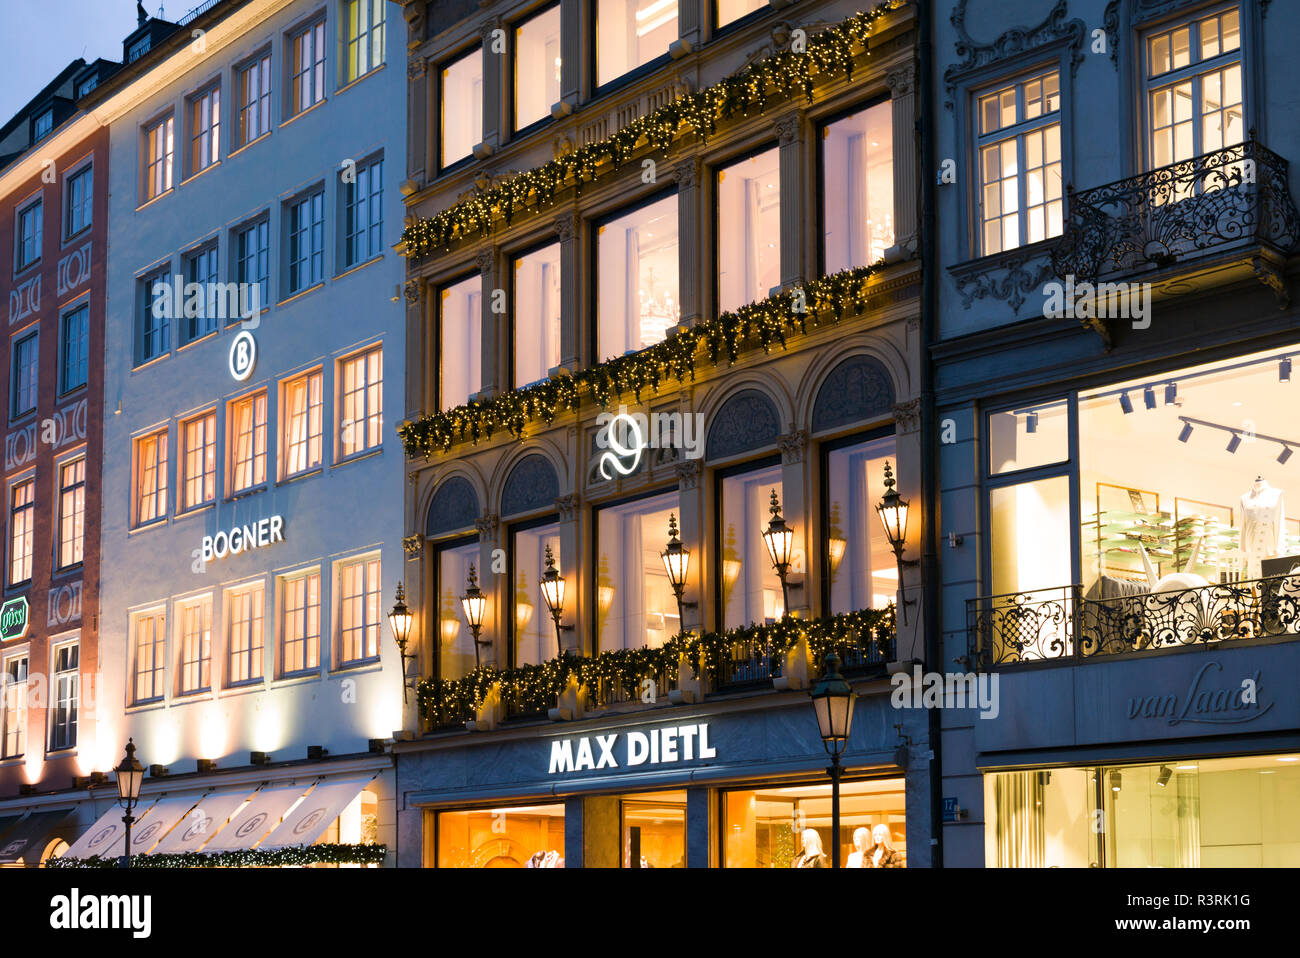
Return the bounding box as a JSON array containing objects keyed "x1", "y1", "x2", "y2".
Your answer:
[{"x1": 723, "y1": 779, "x2": 907, "y2": 868}]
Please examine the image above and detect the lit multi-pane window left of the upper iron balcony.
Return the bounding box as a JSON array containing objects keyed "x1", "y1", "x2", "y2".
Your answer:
[{"x1": 976, "y1": 70, "x2": 1062, "y2": 256}]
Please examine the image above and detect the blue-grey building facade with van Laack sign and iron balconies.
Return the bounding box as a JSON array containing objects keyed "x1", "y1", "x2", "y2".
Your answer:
[{"x1": 932, "y1": 0, "x2": 1300, "y2": 867}]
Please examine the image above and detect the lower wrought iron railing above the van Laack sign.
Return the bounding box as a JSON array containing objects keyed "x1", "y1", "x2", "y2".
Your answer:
[{"x1": 966, "y1": 573, "x2": 1300, "y2": 671}]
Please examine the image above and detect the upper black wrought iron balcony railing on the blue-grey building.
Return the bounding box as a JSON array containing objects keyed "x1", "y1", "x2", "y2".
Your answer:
[{"x1": 1052, "y1": 131, "x2": 1300, "y2": 282}]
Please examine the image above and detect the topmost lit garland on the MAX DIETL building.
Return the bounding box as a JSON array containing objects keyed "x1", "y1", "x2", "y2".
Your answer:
[{"x1": 402, "y1": 0, "x2": 902, "y2": 259}]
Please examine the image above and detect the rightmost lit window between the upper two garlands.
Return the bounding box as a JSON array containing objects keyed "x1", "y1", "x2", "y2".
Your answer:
[{"x1": 822, "y1": 103, "x2": 894, "y2": 273}]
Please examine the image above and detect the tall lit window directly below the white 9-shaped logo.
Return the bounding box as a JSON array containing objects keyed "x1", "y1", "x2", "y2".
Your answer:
[{"x1": 595, "y1": 491, "x2": 681, "y2": 651}]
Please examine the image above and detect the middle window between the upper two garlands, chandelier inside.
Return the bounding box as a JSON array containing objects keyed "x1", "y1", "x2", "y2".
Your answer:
[{"x1": 595, "y1": 194, "x2": 681, "y2": 359}]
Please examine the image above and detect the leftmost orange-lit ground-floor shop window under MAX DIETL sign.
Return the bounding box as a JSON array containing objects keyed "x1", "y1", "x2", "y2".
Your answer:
[{"x1": 436, "y1": 805, "x2": 564, "y2": 868}]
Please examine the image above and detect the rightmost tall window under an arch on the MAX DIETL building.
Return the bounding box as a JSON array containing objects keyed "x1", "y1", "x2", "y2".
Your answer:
[{"x1": 823, "y1": 435, "x2": 898, "y2": 615}]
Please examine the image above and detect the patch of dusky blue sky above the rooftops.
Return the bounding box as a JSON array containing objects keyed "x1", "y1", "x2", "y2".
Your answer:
[{"x1": 0, "y1": 0, "x2": 171, "y2": 126}]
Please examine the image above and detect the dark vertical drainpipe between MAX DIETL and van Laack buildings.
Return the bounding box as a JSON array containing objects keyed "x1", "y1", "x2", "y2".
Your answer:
[{"x1": 917, "y1": 0, "x2": 944, "y2": 868}]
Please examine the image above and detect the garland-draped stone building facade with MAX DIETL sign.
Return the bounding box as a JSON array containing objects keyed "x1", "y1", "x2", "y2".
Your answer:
[{"x1": 394, "y1": 0, "x2": 932, "y2": 867}]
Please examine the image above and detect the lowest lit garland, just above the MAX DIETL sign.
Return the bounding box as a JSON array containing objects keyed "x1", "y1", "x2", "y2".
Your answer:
[{"x1": 416, "y1": 604, "x2": 894, "y2": 728}]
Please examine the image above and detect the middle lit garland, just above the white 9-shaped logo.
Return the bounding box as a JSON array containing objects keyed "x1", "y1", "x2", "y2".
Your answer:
[{"x1": 398, "y1": 263, "x2": 883, "y2": 458}]
